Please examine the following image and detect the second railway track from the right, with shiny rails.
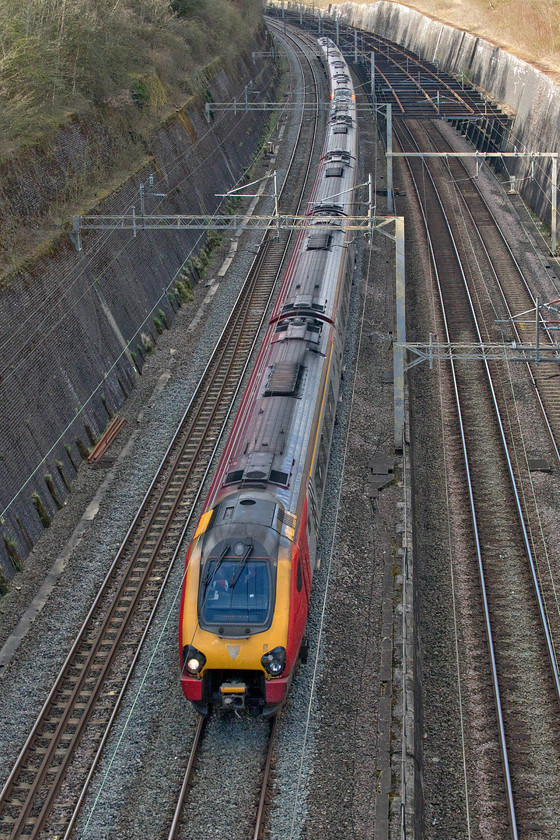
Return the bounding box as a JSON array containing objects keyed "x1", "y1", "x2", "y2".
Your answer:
[{"x1": 398, "y1": 116, "x2": 560, "y2": 837}]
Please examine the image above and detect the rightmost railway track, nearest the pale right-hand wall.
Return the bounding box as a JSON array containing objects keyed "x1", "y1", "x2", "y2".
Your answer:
[{"x1": 406, "y1": 116, "x2": 560, "y2": 667}]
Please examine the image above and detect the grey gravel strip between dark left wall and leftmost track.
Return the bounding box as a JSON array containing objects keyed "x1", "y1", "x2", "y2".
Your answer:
[{"x1": 0, "y1": 27, "x2": 306, "y2": 800}]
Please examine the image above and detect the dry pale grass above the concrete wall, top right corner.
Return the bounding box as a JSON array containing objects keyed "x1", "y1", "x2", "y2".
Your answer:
[{"x1": 302, "y1": 0, "x2": 560, "y2": 78}]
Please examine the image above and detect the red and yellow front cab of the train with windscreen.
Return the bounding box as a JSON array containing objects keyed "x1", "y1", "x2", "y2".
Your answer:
[{"x1": 180, "y1": 489, "x2": 309, "y2": 714}]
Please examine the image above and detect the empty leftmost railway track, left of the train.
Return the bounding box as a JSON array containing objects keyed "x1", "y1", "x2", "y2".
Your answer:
[{"x1": 0, "y1": 26, "x2": 324, "y2": 838}]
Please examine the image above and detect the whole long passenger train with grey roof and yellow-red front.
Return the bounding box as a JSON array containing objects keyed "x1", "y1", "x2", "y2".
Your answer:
[{"x1": 179, "y1": 38, "x2": 358, "y2": 717}]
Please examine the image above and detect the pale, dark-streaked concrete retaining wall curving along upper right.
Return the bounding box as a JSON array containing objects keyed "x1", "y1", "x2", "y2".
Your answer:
[{"x1": 329, "y1": 0, "x2": 560, "y2": 223}]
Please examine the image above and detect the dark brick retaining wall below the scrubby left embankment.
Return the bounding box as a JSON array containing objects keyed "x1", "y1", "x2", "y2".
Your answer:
[{"x1": 0, "y1": 35, "x2": 276, "y2": 578}]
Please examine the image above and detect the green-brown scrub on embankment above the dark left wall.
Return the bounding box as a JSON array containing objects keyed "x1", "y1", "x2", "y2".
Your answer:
[{"x1": 0, "y1": 0, "x2": 262, "y2": 282}]
